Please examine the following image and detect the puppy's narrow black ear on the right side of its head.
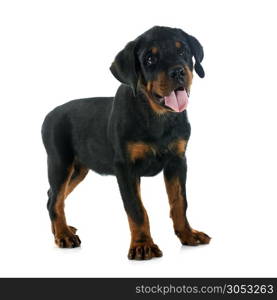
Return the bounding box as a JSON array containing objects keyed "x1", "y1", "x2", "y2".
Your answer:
[{"x1": 182, "y1": 31, "x2": 205, "y2": 78}]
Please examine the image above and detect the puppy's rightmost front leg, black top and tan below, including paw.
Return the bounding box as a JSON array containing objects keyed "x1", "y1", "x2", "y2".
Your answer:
[{"x1": 164, "y1": 156, "x2": 211, "y2": 246}]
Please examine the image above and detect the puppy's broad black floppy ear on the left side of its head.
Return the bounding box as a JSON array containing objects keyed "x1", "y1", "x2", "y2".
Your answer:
[{"x1": 110, "y1": 41, "x2": 138, "y2": 95}]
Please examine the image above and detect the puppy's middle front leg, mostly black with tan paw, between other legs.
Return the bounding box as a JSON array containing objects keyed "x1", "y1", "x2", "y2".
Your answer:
[{"x1": 116, "y1": 163, "x2": 162, "y2": 260}]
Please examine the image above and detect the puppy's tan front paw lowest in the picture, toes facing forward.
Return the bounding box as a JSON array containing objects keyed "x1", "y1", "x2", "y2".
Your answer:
[{"x1": 128, "y1": 242, "x2": 163, "y2": 260}]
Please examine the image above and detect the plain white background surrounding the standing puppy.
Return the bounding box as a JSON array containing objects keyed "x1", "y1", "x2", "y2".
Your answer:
[{"x1": 0, "y1": 0, "x2": 277, "y2": 277}]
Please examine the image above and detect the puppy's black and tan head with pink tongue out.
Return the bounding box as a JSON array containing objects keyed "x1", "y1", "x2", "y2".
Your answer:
[{"x1": 110, "y1": 26, "x2": 205, "y2": 113}]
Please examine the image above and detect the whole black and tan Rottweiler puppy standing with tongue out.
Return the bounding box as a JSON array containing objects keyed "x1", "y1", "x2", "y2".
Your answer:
[{"x1": 42, "y1": 27, "x2": 210, "y2": 259}]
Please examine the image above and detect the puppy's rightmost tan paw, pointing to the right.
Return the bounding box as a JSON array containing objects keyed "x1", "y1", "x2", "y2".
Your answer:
[{"x1": 176, "y1": 229, "x2": 211, "y2": 246}]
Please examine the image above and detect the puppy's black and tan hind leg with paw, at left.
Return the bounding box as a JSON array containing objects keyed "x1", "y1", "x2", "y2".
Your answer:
[{"x1": 47, "y1": 156, "x2": 88, "y2": 248}]
